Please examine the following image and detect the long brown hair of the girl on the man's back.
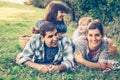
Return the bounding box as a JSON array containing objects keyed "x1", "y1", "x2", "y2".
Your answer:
[{"x1": 45, "y1": 1, "x2": 67, "y2": 22}]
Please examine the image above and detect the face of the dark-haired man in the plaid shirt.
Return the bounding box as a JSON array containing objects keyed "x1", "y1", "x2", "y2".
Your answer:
[{"x1": 42, "y1": 29, "x2": 58, "y2": 47}]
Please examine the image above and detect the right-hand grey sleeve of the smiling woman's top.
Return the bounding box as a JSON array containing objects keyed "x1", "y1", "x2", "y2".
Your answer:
[{"x1": 98, "y1": 40, "x2": 108, "y2": 63}]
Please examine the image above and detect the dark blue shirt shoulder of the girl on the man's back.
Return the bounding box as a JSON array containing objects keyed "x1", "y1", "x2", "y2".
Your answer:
[{"x1": 54, "y1": 21, "x2": 67, "y2": 33}]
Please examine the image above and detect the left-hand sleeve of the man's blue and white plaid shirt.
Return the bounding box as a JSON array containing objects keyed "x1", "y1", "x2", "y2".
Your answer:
[{"x1": 17, "y1": 36, "x2": 39, "y2": 64}]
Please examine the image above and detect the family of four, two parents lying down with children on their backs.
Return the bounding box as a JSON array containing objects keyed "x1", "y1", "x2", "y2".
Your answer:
[{"x1": 16, "y1": 1, "x2": 120, "y2": 73}]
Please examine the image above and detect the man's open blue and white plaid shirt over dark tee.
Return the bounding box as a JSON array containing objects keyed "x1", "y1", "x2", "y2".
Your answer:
[{"x1": 18, "y1": 34, "x2": 74, "y2": 69}]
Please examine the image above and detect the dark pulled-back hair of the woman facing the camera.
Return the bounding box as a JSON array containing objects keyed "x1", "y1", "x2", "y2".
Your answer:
[{"x1": 88, "y1": 20, "x2": 104, "y2": 36}]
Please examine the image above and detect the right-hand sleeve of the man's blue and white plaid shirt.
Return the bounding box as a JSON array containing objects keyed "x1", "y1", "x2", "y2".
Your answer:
[{"x1": 62, "y1": 37, "x2": 74, "y2": 69}]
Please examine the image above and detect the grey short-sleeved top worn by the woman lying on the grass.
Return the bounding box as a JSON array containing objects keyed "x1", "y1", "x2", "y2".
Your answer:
[{"x1": 75, "y1": 38, "x2": 108, "y2": 63}]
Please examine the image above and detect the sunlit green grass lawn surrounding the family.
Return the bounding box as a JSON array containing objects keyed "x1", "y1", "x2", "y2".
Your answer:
[{"x1": 0, "y1": 1, "x2": 120, "y2": 80}]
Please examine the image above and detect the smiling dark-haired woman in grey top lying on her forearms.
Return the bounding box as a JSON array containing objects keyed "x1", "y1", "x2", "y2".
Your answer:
[{"x1": 74, "y1": 21, "x2": 108, "y2": 69}]
